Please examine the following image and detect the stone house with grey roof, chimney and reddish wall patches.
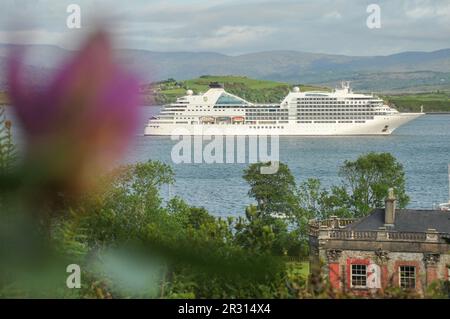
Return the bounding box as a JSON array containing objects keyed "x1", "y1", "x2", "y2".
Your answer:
[{"x1": 309, "y1": 190, "x2": 450, "y2": 295}]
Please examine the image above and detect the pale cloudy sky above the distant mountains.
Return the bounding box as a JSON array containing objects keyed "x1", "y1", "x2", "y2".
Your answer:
[{"x1": 0, "y1": 0, "x2": 450, "y2": 55}]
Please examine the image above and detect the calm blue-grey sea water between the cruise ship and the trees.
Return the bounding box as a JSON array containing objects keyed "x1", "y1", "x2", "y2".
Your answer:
[{"x1": 5, "y1": 107, "x2": 450, "y2": 216}]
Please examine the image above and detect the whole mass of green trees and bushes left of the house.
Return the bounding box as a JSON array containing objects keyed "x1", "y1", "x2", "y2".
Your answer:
[{"x1": 44, "y1": 154, "x2": 414, "y2": 298}]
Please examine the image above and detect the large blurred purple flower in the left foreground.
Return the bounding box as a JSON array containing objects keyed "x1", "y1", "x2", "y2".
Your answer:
[{"x1": 8, "y1": 31, "x2": 139, "y2": 192}]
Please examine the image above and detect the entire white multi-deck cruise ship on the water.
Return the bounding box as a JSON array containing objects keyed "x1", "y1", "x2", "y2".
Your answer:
[{"x1": 145, "y1": 82, "x2": 424, "y2": 136}]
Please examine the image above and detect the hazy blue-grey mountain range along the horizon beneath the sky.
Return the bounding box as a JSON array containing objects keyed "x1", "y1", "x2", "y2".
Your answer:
[{"x1": 0, "y1": 45, "x2": 450, "y2": 92}]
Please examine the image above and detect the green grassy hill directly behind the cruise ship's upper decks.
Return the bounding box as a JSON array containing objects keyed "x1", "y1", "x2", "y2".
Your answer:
[{"x1": 143, "y1": 75, "x2": 329, "y2": 104}]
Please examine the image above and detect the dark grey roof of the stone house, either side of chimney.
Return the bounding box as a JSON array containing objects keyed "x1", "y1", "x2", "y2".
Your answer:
[{"x1": 346, "y1": 208, "x2": 450, "y2": 234}]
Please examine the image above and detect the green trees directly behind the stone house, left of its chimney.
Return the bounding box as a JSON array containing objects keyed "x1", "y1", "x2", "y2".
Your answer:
[{"x1": 297, "y1": 153, "x2": 409, "y2": 219}]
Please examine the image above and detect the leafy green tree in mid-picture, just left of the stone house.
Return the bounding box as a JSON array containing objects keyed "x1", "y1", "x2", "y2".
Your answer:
[{"x1": 236, "y1": 163, "x2": 306, "y2": 257}]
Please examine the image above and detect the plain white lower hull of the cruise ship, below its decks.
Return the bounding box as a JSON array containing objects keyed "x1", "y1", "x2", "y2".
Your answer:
[{"x1": 145, "y1": 113, "x2": 424, "y2": 136}]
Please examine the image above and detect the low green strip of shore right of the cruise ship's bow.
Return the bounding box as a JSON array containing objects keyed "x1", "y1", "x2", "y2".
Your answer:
[{"x1": 382, "y1": 91, "x2": 450, "y2": 112}]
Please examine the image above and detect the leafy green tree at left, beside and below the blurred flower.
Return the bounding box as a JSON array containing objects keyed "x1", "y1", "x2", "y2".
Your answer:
[{"x1": 77, "y1": 161, "x2": 174, "y2": 246}]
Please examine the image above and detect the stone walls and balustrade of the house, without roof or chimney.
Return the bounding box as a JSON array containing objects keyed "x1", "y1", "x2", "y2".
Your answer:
[{"x1": 309, "y1": 217, "x2": 450, "y2": 294}]
